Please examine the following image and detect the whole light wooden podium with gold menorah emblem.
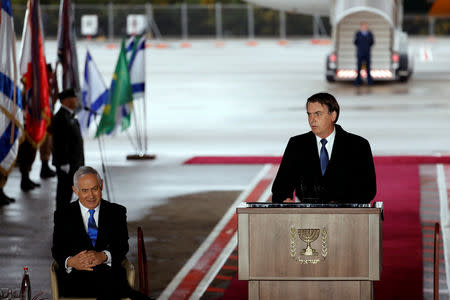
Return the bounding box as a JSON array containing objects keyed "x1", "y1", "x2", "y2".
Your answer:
[{"x1": 237, "y1": 203, "x2": 383, "y2": 300}]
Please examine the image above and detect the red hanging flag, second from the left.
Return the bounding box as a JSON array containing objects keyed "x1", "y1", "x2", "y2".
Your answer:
[{"x1": 20, "y1": 0, "x2": 51, "y2": 148}]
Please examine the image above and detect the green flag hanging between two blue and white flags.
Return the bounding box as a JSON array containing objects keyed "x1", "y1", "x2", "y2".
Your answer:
[{"x1": 95, "y1": 40, "x2": 133, "y2": 137}]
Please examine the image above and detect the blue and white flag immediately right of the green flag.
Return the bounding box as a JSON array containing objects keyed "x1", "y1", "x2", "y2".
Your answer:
[{"x1": 125, "y1": 35, "x2": 145, "y2": 100}]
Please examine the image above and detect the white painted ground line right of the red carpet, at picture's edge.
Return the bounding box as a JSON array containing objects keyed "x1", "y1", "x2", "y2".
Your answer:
[{"x1": 436, "y1": 164, "x2": 450, "y2": 288}]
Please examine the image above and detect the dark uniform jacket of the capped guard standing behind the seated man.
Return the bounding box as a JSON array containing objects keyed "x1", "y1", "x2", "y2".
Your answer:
[{"x1": 52, "y1": 107, "x2": 84, "y2": 173}]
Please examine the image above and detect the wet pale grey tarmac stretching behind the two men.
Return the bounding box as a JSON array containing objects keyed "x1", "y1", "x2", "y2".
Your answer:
[{"x1": 0, "y1": 37, "x2": 450, "y2": 296}]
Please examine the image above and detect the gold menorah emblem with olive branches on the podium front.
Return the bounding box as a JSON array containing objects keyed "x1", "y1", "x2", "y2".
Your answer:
[{"x1": 290, "y1": 226, "x2": 328, "y2": 264}]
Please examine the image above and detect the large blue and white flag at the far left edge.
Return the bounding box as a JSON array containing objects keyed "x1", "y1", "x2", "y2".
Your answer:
[{"x1": 0, "y1": 0, "x2": 24, "y2": 175}]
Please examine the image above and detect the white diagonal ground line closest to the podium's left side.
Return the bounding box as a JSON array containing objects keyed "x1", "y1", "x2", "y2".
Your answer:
[{"x1": 189, "y1": 178, "x2": 275, "y2": 300}]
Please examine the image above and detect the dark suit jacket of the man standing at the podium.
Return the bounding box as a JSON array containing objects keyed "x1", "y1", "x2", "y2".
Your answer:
[{"x1": 272, "y1": 125, "x2": 376, "y2": 203}]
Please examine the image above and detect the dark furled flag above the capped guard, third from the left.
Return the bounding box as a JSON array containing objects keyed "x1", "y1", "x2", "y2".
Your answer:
[{"x1": 57, "y1": 0, "x2": 80, "y2": 91}]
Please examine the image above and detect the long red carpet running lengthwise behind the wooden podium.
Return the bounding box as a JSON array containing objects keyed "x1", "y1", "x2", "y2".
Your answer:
[{"x1": 214, "y1": 158, "x2": 422, "y2": 300}]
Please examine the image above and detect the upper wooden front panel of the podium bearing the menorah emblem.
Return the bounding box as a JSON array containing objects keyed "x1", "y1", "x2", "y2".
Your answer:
[{"x1": 238, "y1": 208, "x2": 381, "y2": 280}]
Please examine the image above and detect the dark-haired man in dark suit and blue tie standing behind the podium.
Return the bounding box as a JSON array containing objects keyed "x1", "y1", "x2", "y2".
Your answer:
[{"x1": 272, "y1": 93, "x2": 376, "y2": 203}]
